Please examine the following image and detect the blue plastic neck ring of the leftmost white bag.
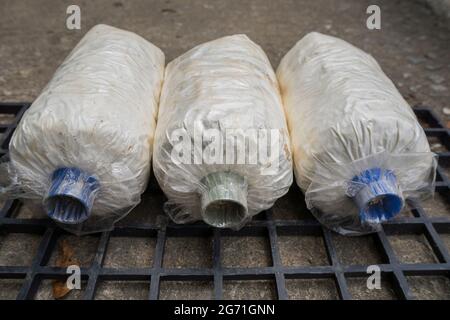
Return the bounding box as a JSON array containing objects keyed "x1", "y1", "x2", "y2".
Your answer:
[{"x1": 44, "y1": 168, "x2": 100, "y2": 224}]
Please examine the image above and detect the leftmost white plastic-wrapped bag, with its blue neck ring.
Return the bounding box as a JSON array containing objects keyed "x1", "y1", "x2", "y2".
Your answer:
[{"x1": 0, "y1": 25, "x2": 164, "y2": 234}]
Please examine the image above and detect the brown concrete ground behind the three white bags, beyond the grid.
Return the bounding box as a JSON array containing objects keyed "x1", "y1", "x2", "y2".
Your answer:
[{"x1": 0, "y1": 0, "x2": 450, "y2": 120}]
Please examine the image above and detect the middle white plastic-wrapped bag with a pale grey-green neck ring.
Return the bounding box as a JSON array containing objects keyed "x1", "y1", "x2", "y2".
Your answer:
[{"x1": 153, "y1": 35, "x2": 292, "y2": 229}]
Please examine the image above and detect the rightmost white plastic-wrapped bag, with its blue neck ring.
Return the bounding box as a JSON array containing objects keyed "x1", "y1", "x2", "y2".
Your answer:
[{"x1": 277, "y1": 32, "x2": 436, "y2": 235}]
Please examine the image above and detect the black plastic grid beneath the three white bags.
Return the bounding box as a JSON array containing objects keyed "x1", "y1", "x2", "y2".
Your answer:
[{"x1": 0, "y1": 103, "x2": 450, "y2": 300}]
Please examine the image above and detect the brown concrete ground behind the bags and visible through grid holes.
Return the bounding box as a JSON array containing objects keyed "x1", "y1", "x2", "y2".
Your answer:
[{"x1": 0, "y1": 0, "x2": 450, "y2": 299}]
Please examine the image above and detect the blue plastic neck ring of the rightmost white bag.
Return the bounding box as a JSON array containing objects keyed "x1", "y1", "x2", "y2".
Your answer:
[{"x1": 352, "y1": 168, "x2": 404, "y2": 223}]
